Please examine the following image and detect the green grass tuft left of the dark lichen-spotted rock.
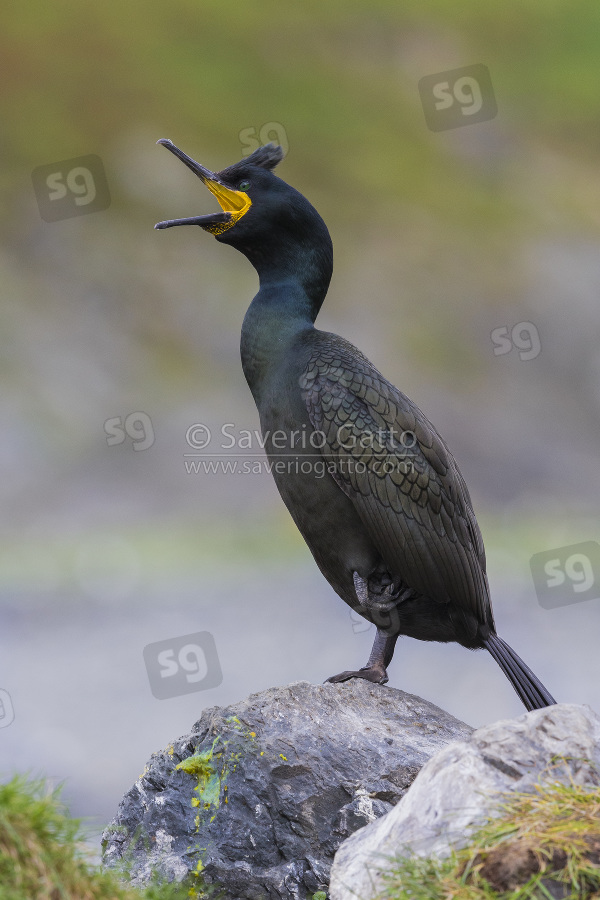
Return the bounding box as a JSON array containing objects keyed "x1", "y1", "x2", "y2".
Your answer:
[{"x1": 0, "y1": 775, "x2": 208, "y2": 900}]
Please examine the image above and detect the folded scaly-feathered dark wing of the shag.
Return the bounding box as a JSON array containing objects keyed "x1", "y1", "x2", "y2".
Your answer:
[{"x1": 300, "y1": 336, "x2": 493, "y2": 623}]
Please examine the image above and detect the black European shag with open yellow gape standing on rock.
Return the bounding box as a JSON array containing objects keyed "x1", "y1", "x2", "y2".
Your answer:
[{"x1": 155, "y1": 140, "x2": 556, "y2": 710}]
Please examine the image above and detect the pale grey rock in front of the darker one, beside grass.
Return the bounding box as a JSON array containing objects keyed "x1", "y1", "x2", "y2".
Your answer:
[{"x1": 330, "y1": 703, "x2": 600, "y2": 900}]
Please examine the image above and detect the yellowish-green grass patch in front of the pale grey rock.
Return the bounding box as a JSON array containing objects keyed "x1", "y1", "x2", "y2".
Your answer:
[{"x1": 378, "y1": 782, "x2": 600, "y2": 900}]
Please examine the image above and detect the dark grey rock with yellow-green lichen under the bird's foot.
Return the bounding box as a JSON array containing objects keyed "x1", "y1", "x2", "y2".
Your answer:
[{"x1": 103, "y1": 679, "x2": 472, "y2": 900}]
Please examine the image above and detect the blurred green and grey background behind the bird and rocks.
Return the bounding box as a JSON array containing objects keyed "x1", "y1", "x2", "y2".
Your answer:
[{"x1": 0, "y1": 0, "x2": 600, "y2": 852}]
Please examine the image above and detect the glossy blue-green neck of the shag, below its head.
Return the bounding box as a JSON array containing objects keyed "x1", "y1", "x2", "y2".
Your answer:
[{"x1": 241, "y1": 233, "x2": 333, "y2": 399}]
